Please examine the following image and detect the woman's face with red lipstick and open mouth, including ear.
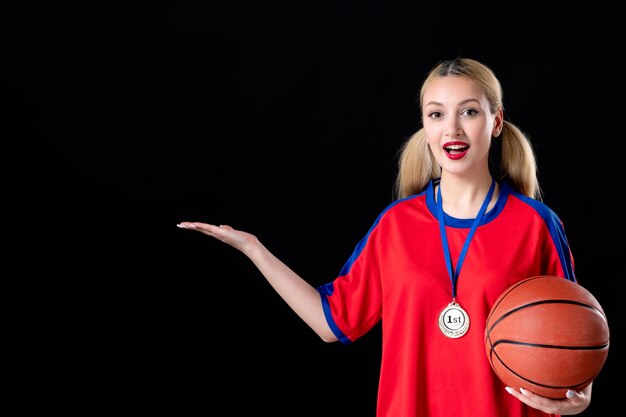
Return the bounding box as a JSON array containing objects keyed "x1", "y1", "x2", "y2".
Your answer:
[{"x1": 422, "y1": 76, "x2": 503, "y2": 175}]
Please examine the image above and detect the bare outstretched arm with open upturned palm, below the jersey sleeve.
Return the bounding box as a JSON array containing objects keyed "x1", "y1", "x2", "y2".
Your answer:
[{"x1": 177, "y1": 222, "x2": 338, "y2": 342}]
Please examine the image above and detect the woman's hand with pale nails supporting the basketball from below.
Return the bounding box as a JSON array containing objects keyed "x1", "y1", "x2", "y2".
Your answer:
[{"x1": 506, "y1": 383, "x2": 593, "y2": 416}]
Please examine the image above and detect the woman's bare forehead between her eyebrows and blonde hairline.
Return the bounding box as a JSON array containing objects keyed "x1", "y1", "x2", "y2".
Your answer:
[{"x1": 423, "y1": 75, "x2": 487, "y2": 106}]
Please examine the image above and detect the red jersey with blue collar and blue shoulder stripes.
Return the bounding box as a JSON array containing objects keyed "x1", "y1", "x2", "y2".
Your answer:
[{"x1": 318, "y1": 182, "x2": 575, "y2": 417}]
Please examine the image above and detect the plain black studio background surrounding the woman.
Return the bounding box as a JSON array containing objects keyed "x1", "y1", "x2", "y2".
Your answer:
[{"x1": 0, "y1": 1, "x2": 626, "y2": 416}]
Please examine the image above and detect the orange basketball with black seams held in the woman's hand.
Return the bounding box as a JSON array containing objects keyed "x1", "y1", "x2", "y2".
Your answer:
[{"x1": 485, "y1": 275, "x2": 609, "y2": 399}]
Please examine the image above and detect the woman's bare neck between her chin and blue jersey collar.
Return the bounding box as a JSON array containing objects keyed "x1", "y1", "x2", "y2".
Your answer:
[{"x1": 437, "y1": 174, "x2": 499, "y2": 219}]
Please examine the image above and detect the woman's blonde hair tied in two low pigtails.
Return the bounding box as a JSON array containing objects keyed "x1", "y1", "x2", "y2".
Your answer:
[{"x1": 395, "y1": 58, "x2": 541, "y2": 200}]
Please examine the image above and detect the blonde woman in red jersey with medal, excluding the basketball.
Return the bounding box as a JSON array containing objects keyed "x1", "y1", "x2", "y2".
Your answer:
[{"x1": 178, "y1": 58, "x2": 592, "y2": 417}]
